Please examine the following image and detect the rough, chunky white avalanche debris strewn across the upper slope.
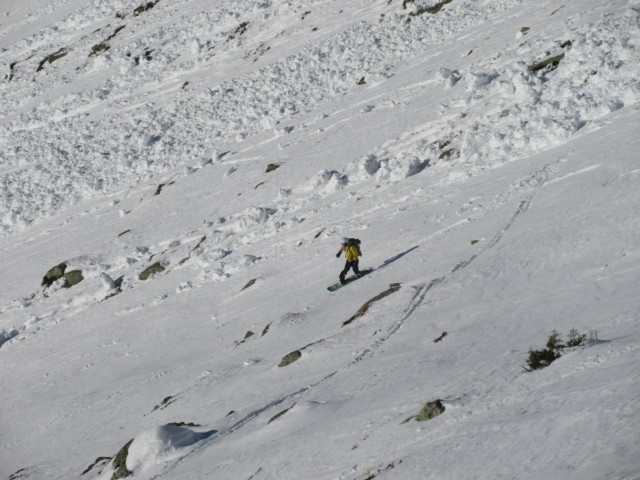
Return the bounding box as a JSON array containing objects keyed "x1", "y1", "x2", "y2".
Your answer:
[{"x1": 7, "y1": 0, "x2": 624, "y2": 232}]
